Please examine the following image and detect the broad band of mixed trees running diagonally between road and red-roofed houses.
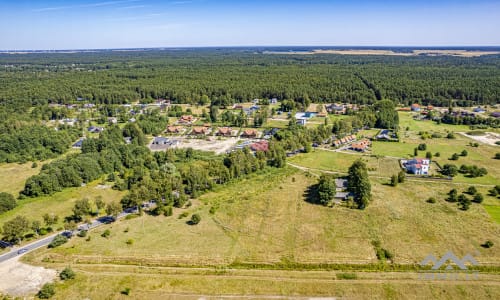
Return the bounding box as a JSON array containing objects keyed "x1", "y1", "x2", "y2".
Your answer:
[{"x1": 22, "y1": 124, "x2": 285, "y2": 202}]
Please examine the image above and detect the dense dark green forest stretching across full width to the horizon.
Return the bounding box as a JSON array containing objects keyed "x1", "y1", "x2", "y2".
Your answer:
[{"x1": 0, "y1": 49, "x2": 500, "y2": 106}]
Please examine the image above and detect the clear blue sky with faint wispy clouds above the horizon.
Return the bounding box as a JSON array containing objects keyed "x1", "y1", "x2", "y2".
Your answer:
[{"x1": 0, "y1": 0, "x2": 500, "y2": 50}]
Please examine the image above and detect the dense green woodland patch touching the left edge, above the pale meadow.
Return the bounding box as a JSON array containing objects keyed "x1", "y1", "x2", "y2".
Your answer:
[{"x1": 0, "y1": 123, "x2": 81, "y2": 162}]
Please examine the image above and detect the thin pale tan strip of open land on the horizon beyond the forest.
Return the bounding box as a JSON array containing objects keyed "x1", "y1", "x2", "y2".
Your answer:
[{"x1": 265, "y1": 49, "x2": 500, "y2": 57}]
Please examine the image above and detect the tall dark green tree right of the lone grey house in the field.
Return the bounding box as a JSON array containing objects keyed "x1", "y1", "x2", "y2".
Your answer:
[{"x1": 348, "y1": 160, "x2": 372, "y2": 209}]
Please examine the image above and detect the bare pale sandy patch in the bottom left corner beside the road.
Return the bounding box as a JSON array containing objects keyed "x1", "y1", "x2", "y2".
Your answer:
[{"x1": 0, "y1": 257, "x2": 57, "y2": 296}]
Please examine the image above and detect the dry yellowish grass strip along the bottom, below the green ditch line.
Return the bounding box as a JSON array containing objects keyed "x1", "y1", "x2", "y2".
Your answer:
[{"x1": 24, "y1": 265, "x2": 500, "y2": 300}]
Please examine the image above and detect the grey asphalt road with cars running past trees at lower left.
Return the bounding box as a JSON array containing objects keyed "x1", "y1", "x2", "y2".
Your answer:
[{"x1": 0, "y1": 209, "x2": 137, "y2": 263}]
